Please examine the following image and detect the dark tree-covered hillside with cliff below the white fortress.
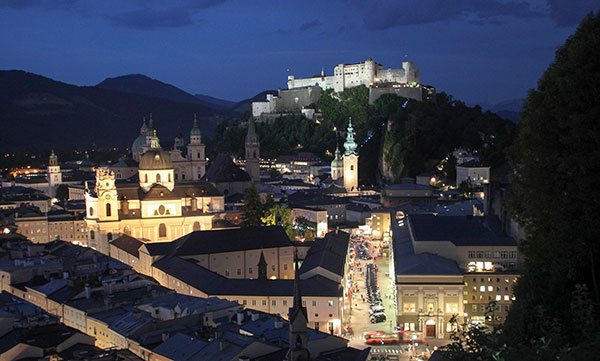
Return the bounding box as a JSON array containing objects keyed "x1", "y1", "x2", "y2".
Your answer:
[{"x1": 209, "y1": 86, "x2": 516, "y2": 185}]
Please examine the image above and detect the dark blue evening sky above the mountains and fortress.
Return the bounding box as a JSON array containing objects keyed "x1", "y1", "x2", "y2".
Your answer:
[{"x1": 0, "y1": 0, "x2": 600, "y2": 103}]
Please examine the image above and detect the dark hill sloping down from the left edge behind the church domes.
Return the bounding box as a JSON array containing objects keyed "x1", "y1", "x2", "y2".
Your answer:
[{"x1": 0, "y1": 70, "x2": 231, "y2": 149}]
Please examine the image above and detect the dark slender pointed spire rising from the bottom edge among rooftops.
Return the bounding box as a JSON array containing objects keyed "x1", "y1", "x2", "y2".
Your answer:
[{"x1": 285, "y1": 252, "x2": 310, "y2": 361}]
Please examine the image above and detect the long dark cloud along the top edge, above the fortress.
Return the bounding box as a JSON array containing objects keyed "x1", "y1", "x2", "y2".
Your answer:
[{"x1": 349, "y1": 0, "x2": 547, "y2": 30}]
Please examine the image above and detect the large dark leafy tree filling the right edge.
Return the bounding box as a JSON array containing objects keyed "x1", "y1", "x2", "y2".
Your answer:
[{"x1": 505, "y1": 14, "x2": 600, "y2": 359}]
